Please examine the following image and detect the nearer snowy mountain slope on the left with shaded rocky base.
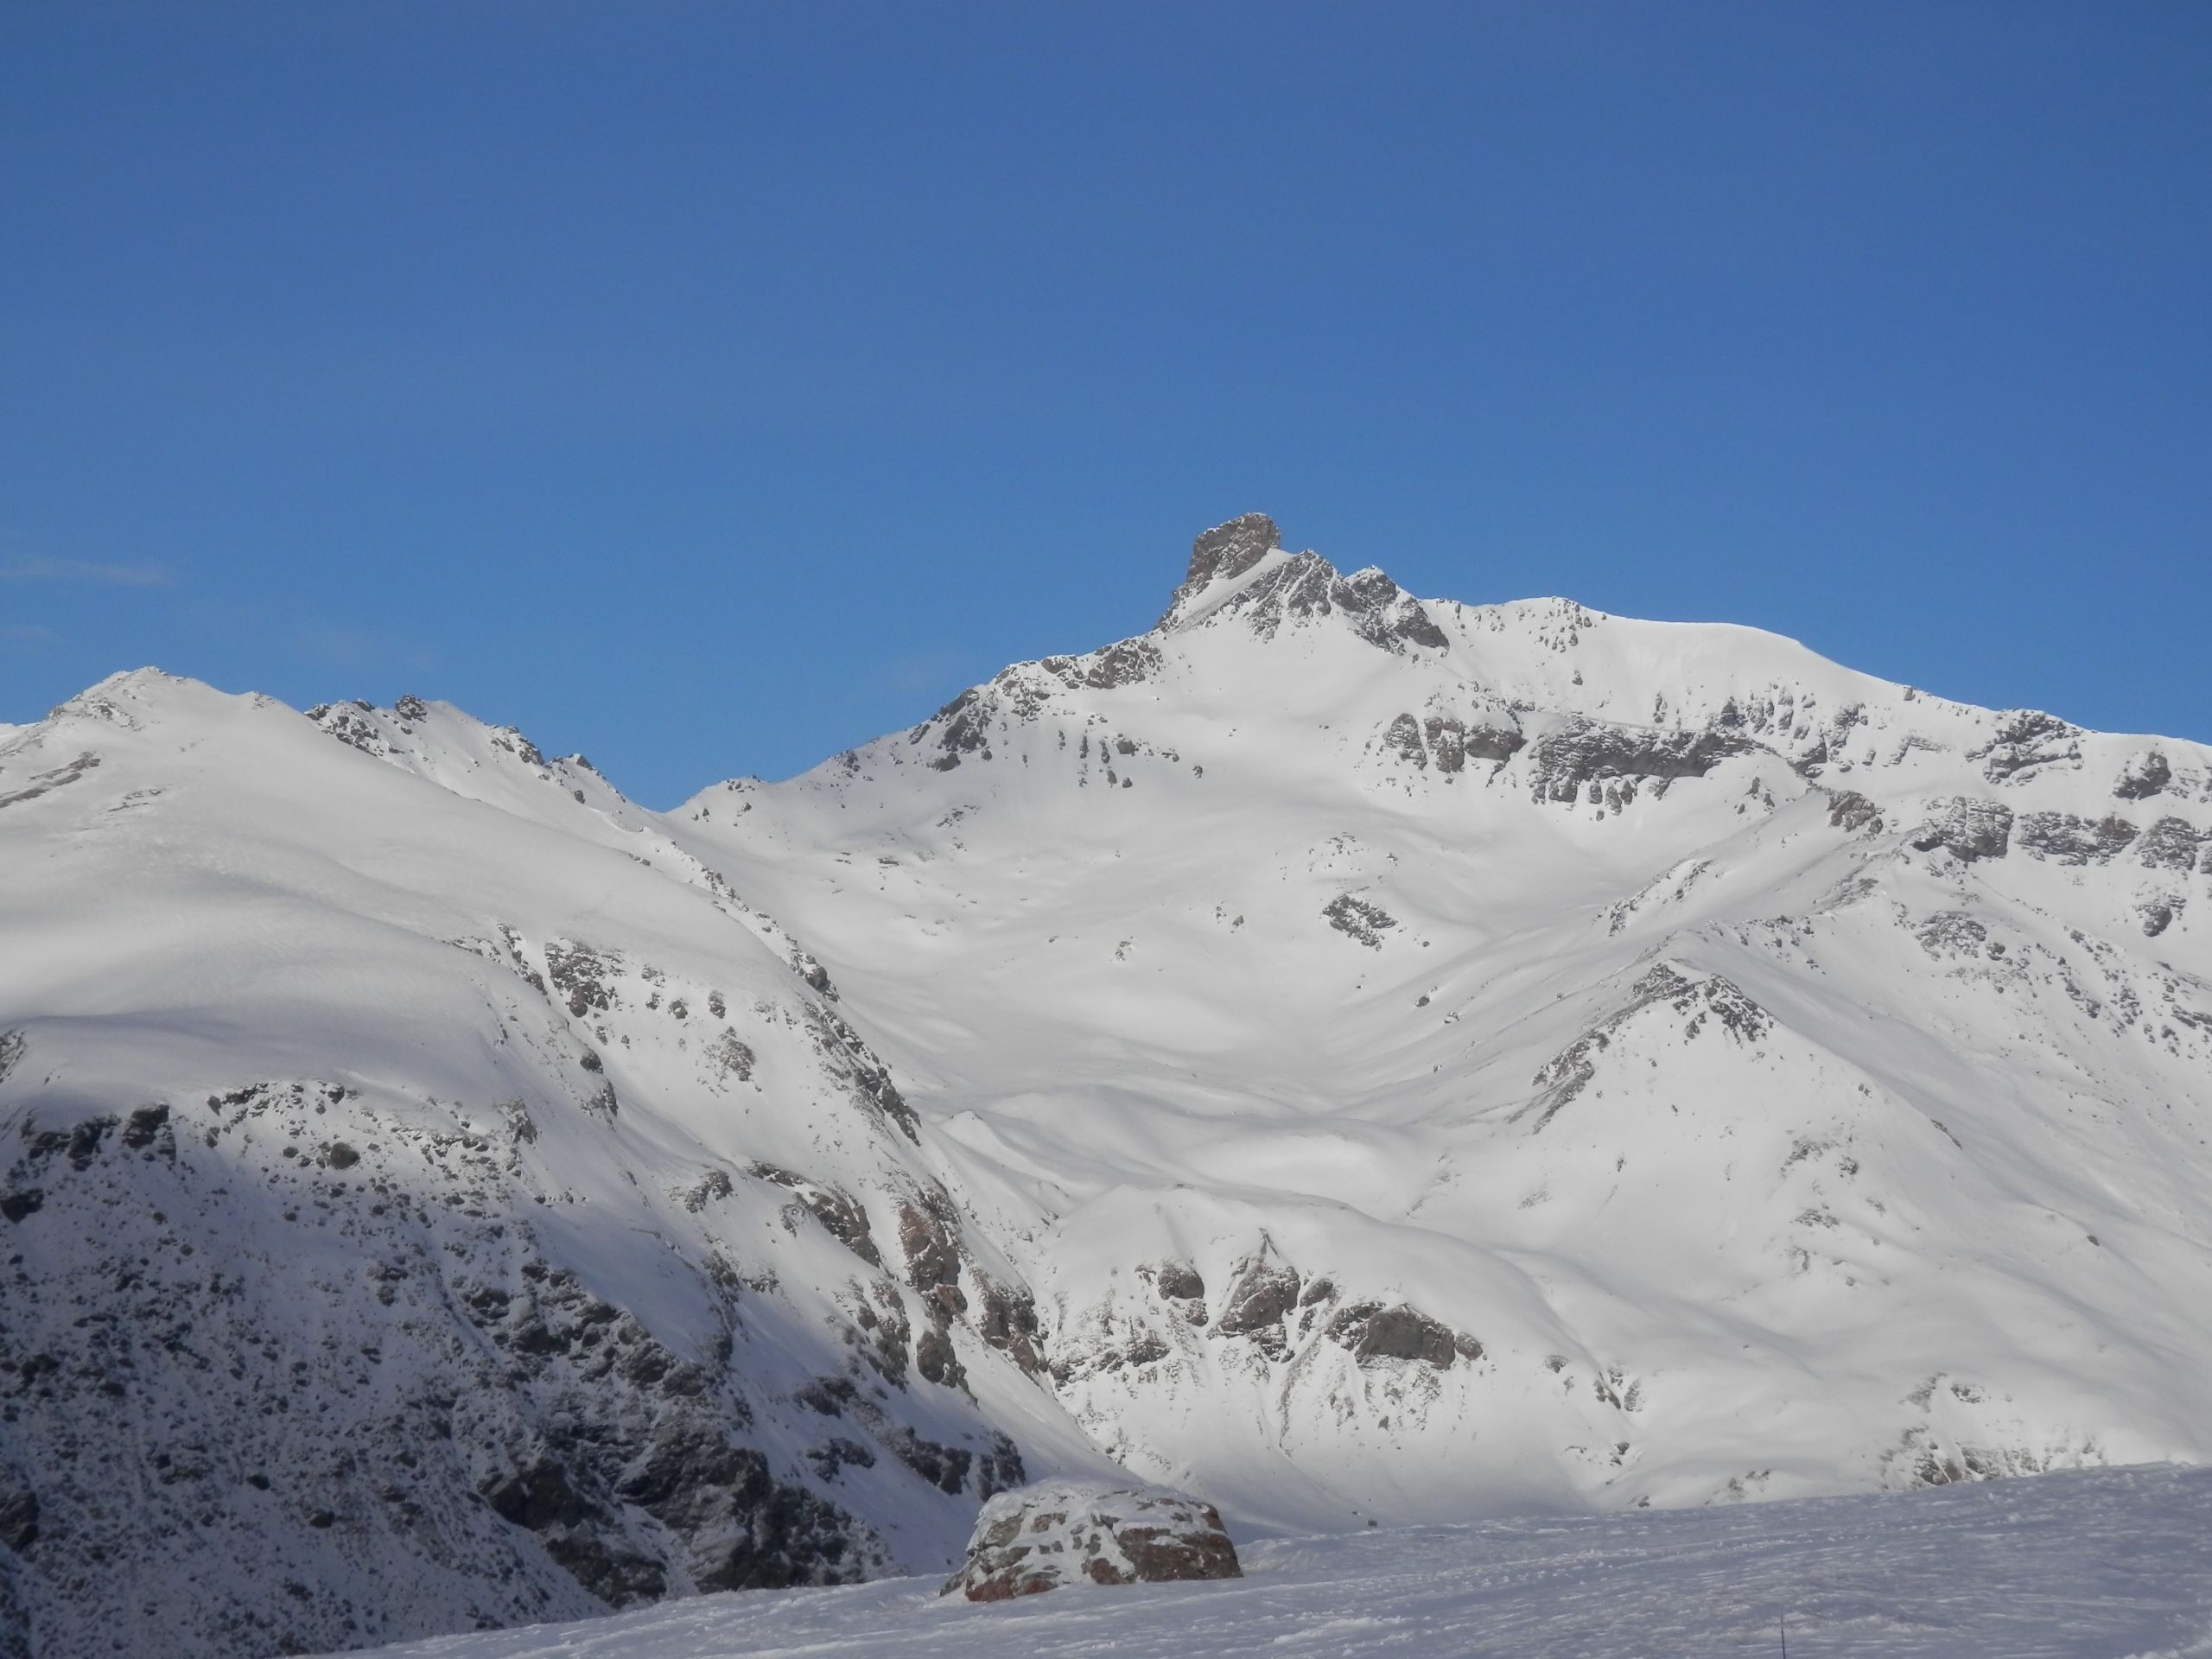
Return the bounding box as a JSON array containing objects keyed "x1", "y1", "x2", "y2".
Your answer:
[{"x1": 0, "y1": 672, "x2": 1106, "y2": 1655}]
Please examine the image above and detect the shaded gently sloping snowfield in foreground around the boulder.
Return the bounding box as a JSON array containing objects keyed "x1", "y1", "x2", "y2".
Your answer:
[{"x1": 353, "y1": 1466, "x2": 2212, "y2": 1659}]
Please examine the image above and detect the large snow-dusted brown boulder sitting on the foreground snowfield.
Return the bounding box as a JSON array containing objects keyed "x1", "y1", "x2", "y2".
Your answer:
[{"x1": 944, "y1": 1480, "x2": 1243, "y2": 1601}]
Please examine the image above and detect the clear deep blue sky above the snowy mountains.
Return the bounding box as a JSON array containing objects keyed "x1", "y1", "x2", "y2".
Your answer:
[{"x1": 0, "y1": 0, "x2": 2212, "y2": 805}]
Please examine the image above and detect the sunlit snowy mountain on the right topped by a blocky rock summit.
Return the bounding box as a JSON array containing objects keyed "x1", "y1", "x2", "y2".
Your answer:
[{"x1": 671, "y1": 515, "x2": 2212, "y2": 1526}]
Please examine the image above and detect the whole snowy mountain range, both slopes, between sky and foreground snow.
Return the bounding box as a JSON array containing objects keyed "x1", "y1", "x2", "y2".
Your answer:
[{"x1": 0, "y1": 515, "x2": 2212, "y2": 1652}]
